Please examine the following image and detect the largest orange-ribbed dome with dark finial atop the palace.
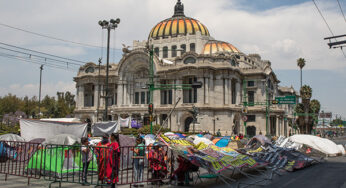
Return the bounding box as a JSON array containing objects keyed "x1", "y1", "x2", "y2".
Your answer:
[{"x1": 149, "y1": 0, "x2": 210, "y2": 38}]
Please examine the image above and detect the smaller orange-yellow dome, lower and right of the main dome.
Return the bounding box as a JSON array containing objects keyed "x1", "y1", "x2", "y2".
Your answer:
[{"x1": 202, "y1": 40, "x2": 240, "y2": 55}]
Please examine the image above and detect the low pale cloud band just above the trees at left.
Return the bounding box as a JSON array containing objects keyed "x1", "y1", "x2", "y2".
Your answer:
[{"x1": 0, "y1": 81, "x2": 76, "y2": 97}]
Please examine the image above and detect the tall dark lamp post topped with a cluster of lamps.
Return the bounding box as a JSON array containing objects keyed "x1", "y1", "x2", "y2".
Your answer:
[{"x1": 99, "y1": 18, "x2": 120, "y2": 120}]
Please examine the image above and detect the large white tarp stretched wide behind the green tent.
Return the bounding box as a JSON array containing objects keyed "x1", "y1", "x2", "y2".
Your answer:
[{"x1": 19, "y1": 119, "x2": 87, "y2": 140}]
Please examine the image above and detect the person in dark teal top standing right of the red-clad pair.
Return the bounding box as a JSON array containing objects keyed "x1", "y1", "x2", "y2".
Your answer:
[{"x1": 133, "y1": 137, "x2": 145, "y2": 187}]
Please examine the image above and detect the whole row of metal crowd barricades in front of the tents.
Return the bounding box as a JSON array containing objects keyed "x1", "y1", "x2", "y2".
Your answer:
[{"x1": 0, "y1": 141, "x2": 174, "y2": 186}]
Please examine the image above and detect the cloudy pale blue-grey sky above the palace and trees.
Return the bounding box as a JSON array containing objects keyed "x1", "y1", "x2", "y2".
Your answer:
[{"x1": 0, "y1": 0, "x2": 346, "y2": 118}]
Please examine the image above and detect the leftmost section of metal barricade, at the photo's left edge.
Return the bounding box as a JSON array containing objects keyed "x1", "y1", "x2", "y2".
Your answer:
[{"x1": 0, "y1": 140, "x2": 42, "y2": 184}]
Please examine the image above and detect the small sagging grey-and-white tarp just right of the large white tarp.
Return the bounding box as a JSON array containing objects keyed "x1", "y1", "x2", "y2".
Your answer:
[{"x1": 91, "y1": 121, "x2": 119, "y2": 136}]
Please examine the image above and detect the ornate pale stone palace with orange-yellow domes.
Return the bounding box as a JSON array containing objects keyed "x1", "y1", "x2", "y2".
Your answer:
[{"x1": 74, "y1": 0, "x2": 297, "y2": 136}]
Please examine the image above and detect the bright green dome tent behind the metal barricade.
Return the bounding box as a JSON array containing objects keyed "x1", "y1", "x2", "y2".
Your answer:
[{"x1": 26, "y1": 146, "x2": 97, "y2": 178}]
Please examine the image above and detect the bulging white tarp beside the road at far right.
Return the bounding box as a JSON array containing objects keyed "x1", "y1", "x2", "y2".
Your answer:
[{"x1": 281, "y1": 134, "x2": 345, "y2": 155}]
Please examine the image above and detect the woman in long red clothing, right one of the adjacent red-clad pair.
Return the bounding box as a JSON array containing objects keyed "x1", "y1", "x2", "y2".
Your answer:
[{"x1": 106, "y1": 133, "x2": 120, "y2": 188}]
